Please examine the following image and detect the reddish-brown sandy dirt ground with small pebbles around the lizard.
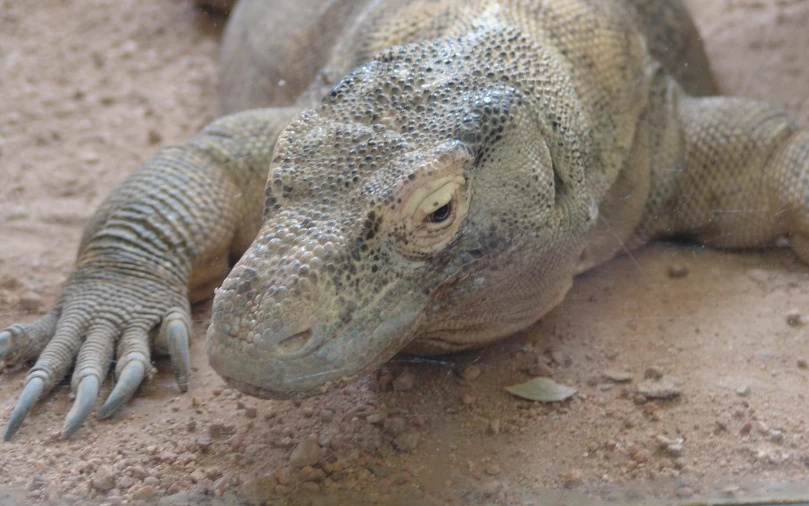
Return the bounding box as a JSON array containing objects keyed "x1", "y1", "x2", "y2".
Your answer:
[{"x1": 0, "y1": 0, "x2": 809, "y2": 505}]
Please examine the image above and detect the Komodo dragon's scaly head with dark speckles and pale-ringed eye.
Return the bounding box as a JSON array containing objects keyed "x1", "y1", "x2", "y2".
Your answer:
[{"x1": 208, "y1": 34, "x2": 596, "y2": 397}]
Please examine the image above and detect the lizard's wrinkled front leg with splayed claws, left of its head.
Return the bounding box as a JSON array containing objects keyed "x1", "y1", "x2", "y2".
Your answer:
[{"x1": 0, "y1": 109, "x2": 296, "y2": 439}]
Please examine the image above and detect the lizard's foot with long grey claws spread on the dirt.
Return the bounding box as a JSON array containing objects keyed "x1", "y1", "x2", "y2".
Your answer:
[{"x1": 0, "y1": 270, "x2": 191, "y2": 441}]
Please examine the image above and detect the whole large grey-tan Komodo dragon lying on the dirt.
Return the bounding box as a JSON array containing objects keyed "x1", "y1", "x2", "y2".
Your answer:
[{"x1": 0, "y1": 0, "x2": 809, "y2": 439}]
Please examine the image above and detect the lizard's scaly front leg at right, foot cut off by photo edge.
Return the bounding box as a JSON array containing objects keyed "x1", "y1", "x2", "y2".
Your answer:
[{"x1": 641, "y1": 97, "x2": 809, "y2": 256}]
